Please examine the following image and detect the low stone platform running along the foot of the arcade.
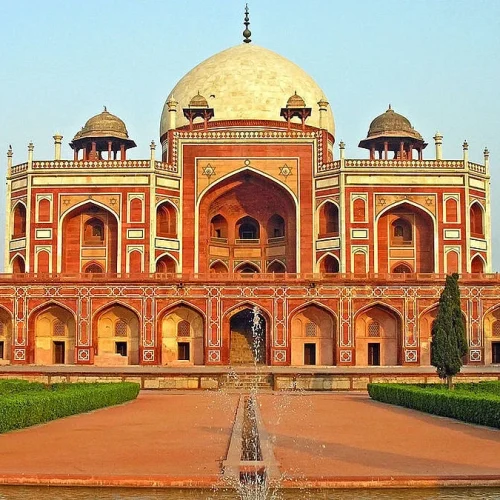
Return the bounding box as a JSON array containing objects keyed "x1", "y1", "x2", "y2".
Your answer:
[{"x1": 0, "y1": 365, "x2": 500, "y2": 391}]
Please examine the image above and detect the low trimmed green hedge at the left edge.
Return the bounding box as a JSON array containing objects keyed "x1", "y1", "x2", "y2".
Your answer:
[{"x1": 0, "y1": 382, "x2": 139, "y2": 433}]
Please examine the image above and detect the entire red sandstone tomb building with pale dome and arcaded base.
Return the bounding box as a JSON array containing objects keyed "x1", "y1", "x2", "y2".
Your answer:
[{"x1": 0, "y1": 14, "x2": 500, "y2": 370}]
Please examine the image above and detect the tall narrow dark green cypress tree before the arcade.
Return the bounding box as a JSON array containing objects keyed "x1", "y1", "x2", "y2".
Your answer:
[{"x1": 431, "y1": 273, "x2": 467, "y2": 389}]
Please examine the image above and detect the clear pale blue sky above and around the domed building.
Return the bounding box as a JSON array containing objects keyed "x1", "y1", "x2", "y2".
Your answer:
[{"x1": 0, "y1": 0, "x2": 500, "y2": 271}]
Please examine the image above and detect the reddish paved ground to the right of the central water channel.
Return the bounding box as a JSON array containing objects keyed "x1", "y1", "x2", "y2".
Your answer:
[{"x1": 260, "y1": 393, "x2": 500, "y2": 482}]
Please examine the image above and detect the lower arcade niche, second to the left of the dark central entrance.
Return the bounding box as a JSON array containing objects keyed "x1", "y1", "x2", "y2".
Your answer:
[{"x1": 93, "y1": 304, "x2": 140, "y2": 366}]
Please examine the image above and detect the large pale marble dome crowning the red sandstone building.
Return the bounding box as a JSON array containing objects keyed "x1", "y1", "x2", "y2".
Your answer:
[{"x1": 160, "y1": 43, "x2": 335, "y2": 137}]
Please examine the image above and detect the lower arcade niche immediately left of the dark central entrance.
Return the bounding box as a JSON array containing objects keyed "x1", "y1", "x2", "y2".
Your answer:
[{"x1": 159, "y1": 305, "x2": 204, "y2": 365}]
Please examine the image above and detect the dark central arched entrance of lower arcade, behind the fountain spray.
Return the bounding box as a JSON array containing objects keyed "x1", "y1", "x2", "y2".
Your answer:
[{"x1": 229, "y1": 308, "x2": 266, "y2": 365}]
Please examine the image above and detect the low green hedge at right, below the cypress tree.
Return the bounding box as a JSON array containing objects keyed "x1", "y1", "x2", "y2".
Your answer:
[{"x1": 368, "y1": 382, "x2": 500, "y2": 428}]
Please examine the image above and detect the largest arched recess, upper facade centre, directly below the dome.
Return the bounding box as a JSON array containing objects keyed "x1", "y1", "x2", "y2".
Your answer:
[{"x1": 197, "y1": 169, "x2": 296, "y2": 272}]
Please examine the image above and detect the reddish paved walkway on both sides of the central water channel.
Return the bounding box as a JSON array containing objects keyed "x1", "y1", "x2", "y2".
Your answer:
[{"x1": 0, "y1": 392, "x2": 500, "y2": 486}]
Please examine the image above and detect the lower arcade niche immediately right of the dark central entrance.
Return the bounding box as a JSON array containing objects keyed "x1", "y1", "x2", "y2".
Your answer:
[{"x1": 290, "y1": 305, "x2": 337, "y2": 366}]
